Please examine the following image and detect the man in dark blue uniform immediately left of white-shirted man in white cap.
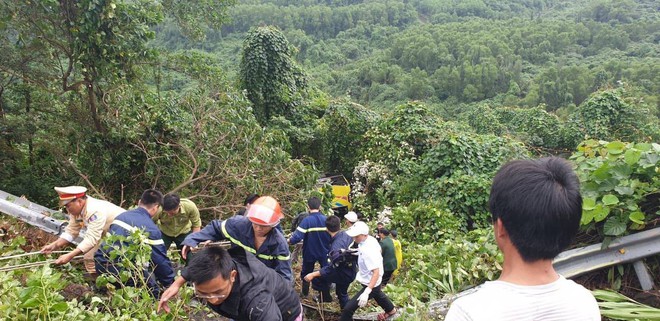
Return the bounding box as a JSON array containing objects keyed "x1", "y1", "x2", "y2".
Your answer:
[{"x1": 305, "y1": 215, "x2": 357, "y2": 309}]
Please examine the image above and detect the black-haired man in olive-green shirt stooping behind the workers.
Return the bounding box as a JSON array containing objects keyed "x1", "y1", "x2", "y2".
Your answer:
[{"x1": 153, "y1": 194, "x2": 202, "y2": 251}]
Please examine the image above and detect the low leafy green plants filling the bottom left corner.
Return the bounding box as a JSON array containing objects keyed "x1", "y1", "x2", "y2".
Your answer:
[{"x1": 0, "y1": 232, "x2": 195, "y2": 321}]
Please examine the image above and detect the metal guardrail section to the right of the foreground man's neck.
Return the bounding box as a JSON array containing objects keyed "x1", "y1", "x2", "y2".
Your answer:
[{"x1": 553, "y1": 227, "x2": 660, "y2": 291}]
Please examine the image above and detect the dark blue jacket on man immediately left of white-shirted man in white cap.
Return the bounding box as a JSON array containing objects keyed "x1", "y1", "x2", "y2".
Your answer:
[{"x1": 320, "y1": 231, "x2": 357, "y2": 283}]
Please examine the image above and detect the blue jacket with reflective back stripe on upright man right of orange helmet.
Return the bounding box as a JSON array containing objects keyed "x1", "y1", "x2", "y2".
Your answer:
[{"x1": 289, "y1": 212, "x2": 330, "y2": 262}]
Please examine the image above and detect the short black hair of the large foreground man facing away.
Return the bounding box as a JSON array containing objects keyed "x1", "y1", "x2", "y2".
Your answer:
[{"x1": 488, "y1": 157, "x2": 582, "y2": 262}]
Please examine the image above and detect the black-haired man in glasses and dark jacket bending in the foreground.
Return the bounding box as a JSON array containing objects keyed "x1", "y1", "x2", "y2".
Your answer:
[{"x1": 157, "y1": 247, "x2": 303, "y2": 321}]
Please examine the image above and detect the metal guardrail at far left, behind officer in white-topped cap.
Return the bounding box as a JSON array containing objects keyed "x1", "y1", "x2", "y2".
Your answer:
[{"x1": 0, "y1": 191, "x2": 84, "y2": 244}]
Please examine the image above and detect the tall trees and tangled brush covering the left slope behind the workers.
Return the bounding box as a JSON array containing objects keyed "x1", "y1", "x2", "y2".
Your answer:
[{"x1": 0, "y1": 1, "x2": 317, "y2": 214}]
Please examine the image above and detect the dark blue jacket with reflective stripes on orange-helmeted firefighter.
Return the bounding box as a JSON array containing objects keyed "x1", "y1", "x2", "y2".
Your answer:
[{"x1": 183, "y1": 216, "x2": 293, "y2": 281}]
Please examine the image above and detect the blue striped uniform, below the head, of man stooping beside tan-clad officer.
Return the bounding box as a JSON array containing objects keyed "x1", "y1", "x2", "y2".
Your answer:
[{"x1": 94, "y1": 207, "x2": 174, "y2": 295}]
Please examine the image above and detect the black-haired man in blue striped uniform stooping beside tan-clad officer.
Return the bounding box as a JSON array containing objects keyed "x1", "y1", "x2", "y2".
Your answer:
[{"x1": 94, "y1": 189, "x2": 174, "y2": 297}]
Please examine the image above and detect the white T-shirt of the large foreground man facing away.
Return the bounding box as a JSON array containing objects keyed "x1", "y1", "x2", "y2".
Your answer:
[{"x1": 445, "y1": 276, "x2": 600, "y2": 321}]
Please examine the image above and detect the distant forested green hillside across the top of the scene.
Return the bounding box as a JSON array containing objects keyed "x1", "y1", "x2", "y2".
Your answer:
[{"x1": 155, "y1": 0, "x2": 660, "y2": 114}]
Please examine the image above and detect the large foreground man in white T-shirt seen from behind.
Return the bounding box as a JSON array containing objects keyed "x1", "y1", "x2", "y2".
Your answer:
[{"x1": 445, "y1": 157, "x2": 600, "y2": 321}]
